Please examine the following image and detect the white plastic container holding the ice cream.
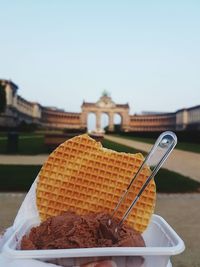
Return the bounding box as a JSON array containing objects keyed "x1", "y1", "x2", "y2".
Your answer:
[{"x1": 3, "y1": 215, "x2": 185, "y2": 267}]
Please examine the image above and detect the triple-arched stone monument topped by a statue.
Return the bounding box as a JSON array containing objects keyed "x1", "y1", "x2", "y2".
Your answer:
[{"x1": 81, "y1": 92, "x2": 130, "y2": 132}]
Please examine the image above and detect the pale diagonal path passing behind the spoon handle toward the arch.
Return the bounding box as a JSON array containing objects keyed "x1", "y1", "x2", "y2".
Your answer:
[{"x1": 105, "y1": 135, "x2": 200, "y2": 182}]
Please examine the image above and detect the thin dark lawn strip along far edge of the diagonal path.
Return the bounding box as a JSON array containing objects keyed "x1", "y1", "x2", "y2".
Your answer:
[{"x1": 114, "y1": 134, "x2": 200, "y2": 153}]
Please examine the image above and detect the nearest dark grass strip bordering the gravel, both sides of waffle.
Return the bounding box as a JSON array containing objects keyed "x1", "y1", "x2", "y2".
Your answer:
[{"x1": 0, "y1": 162, "x2": 200, "y2": 193}]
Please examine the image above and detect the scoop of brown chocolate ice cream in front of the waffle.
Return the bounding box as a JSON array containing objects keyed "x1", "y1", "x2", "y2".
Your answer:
[{"x1": 21, "y1": 211, "x2": 145, "y2": 250}]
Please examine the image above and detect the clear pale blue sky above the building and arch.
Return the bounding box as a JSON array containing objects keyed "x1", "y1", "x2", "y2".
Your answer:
[{"x1": 0, "y1": 0, "x2": 200, "y2": 113}]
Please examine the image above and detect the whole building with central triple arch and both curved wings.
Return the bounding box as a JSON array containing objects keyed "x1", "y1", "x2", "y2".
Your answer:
[{"x1": 0, "y1": 80, "x2": 200, "y2": 132}]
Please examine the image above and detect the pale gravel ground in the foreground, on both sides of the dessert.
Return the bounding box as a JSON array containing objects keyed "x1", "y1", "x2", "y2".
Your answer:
[{"x1": 0, "y1": 193, "x2": 200, "y2": 267}]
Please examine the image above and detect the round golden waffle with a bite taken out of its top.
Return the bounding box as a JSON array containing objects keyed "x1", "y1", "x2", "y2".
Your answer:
[{"x1": 36, "y1": 134, "x2": 156, "y2": 232}]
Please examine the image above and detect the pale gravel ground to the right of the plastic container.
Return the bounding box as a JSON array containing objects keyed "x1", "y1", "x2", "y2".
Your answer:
[{"x1": 155, "y1": 194, "x2": 200, "y2": 267}]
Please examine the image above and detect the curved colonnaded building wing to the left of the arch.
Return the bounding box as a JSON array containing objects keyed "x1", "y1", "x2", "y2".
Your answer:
[{"x1": 0, "y1": 80, "x2": 82, "y2": 129}]
